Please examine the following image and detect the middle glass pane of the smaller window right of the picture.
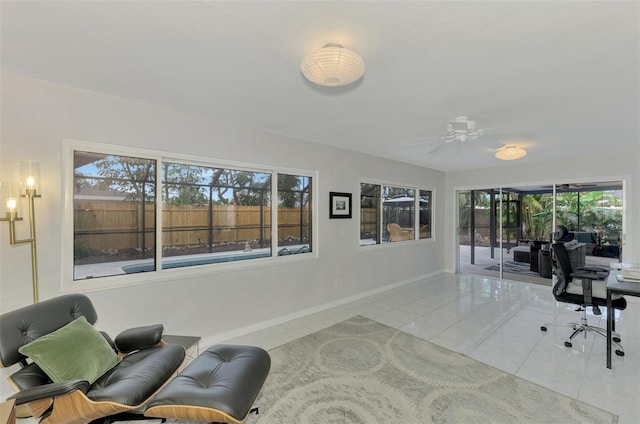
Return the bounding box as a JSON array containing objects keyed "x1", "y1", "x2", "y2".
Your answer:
[{"x1": 382, "y1": 186, "x2": 415, "y2": 242}]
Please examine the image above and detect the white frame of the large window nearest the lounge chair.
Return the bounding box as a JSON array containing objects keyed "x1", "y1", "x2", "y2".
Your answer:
[{"x1": 61, "y1": 138, "x2": 319, "y2": 292}]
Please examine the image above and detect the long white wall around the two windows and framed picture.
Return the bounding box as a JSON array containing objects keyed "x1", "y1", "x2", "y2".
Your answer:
[{"x1": 0, "y1": 73, "x2": 444, "y2": 394}]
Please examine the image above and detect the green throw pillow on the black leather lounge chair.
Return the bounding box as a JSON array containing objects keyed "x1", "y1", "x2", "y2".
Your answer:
[{"x1": 18, "y1": 317, "x2": 122, "y2": 384}]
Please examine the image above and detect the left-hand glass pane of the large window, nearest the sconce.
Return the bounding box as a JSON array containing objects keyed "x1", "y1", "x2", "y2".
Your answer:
[{"x1": 73, "y1": 151, "x2": 156, "y2": 280}]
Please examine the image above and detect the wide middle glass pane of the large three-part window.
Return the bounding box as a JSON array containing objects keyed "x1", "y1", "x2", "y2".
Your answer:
[{"x1": 162, "y1": 162, "x2": 271, "y2": 269}]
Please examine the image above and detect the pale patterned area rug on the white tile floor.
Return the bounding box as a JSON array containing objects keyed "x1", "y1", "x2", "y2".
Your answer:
[{"x1": 240, "y1": 316, "x2": 617, "y2": 424}]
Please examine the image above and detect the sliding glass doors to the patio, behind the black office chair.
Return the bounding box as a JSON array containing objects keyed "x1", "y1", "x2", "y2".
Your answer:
[{"x1": 457, "y1": 181, "x2": 623, "y2": 285}]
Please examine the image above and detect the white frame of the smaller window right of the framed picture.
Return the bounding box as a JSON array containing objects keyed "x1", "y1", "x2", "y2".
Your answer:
[{"x1": 357, "y1": 179, "x2": 436, "y2": 245}]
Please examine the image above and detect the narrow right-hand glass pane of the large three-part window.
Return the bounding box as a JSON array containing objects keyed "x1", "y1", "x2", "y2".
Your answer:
[{"x1": 278, "y1": 174, "x2": 311, "y2": 256}]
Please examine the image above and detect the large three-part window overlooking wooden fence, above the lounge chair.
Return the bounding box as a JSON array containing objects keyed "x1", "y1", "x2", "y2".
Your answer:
[{"x1": 72, "y1": 149, "x2": 313, "y2": 280}]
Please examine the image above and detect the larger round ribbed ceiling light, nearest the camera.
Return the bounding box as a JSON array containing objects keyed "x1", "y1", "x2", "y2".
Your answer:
[{"x1": 300, "y1": 43, "x2": 364, "y2": 87}]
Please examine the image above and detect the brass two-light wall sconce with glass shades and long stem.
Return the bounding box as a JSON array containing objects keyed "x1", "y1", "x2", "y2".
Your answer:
[{"x1": 0, "y1": 161, "x2": 40, "y2": 303}]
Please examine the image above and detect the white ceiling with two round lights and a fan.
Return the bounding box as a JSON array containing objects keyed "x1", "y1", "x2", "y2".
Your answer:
[{"x1": 0, "y1": 0, "x2": 640, "y2": 171}]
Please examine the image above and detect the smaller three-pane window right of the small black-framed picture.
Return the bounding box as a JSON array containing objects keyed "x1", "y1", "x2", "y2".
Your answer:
[{"x1": 360, "y1": 183, "x2": 432, "y2": 246}]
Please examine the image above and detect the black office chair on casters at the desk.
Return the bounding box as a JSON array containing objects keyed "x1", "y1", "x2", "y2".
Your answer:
[{"x1": 540, "y1": 243, "x2": 627, "y2": 356}]
